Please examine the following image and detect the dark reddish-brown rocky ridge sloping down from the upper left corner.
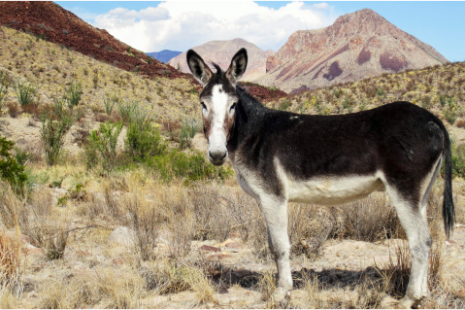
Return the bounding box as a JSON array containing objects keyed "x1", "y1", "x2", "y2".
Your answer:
[{"x1": 0, "y1": 0, "x2": 188, "y2": 78}]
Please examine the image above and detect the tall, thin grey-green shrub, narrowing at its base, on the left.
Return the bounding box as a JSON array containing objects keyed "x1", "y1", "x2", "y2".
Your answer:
[{"x1": 40, "y1": 99, "x2": 77, "y2": 165}]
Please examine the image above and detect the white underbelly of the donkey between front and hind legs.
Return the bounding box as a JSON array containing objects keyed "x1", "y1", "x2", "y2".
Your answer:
[{"x1": 288, "y1": 175, "x2": 384, "y2": 205}]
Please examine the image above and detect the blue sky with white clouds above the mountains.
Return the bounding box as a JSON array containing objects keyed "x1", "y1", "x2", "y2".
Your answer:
[{"x1": 54, "y1": 0, "x2": 465, "y2": 61}]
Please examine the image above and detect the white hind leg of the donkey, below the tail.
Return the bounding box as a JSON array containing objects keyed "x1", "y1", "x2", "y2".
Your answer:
[{"x1": 386, "y1": 186, "x2": 432, "y2": 309}]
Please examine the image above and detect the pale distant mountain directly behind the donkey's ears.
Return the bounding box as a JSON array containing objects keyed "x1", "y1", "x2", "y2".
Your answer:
[{"x1": 168, "y1": 38, "x2": 274, "y2": 81}]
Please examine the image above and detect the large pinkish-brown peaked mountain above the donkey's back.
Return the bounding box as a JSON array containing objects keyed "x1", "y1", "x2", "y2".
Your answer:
[{"x1": 255, "y1": 9, "x2": 448, "y2": 92}]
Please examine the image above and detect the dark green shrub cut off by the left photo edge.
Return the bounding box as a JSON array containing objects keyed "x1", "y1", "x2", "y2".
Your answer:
[{"x1": 0, "y1": 137, "x2": 27, "y2": 192}]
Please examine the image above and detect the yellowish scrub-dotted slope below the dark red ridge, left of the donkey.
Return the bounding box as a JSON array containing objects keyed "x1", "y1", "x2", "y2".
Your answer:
[{"x1": 0, "y1": 27, "x2": 200, "y2": 119}]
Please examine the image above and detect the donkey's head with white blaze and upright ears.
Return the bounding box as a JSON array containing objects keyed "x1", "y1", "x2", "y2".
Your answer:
[{"x1": 187, "y1": 48, "x2": 247, "y2": 166}]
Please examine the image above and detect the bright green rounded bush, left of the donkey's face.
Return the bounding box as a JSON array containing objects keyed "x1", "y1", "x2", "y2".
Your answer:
[{"x1": 124, "y1": 113, "x2": 168, "y2": 161}]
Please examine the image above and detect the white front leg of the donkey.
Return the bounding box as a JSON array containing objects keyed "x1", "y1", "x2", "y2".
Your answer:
[{"x1": 260, "y1": 196, "x2": 292, "y2": 302}]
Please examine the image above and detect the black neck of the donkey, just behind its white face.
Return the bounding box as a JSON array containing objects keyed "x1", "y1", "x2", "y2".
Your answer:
[{"x1": 228, "y1": 86, "x2": 269, "y2": 153}]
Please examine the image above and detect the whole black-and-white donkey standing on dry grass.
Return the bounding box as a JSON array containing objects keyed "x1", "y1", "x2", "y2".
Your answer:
[{"x1": 187, "y1": 48, "x2": 455, "y2": 308}]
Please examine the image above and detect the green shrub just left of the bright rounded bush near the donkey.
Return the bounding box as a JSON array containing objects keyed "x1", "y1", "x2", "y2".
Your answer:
[{"x1": 85, "y1": 122, "x2": 123, "y2": 169}]
